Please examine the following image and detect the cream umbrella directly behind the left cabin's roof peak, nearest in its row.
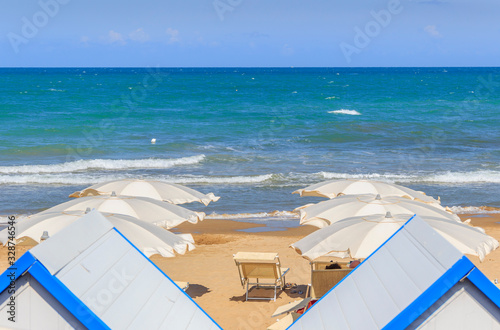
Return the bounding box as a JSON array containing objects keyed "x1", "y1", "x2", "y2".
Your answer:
[{"x1": 0, "y1": 211, "x2": 194, "y2": 257}]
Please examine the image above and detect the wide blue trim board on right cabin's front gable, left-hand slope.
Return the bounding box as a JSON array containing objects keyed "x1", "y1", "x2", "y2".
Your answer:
[{"x1": 384, "y1": 256, "x2": 475, "y2": 329}]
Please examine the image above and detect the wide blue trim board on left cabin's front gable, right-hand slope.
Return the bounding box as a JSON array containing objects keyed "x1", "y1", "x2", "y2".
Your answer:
[{"x1": 29, "y1": 260, "x2": 110, "y2": 329}]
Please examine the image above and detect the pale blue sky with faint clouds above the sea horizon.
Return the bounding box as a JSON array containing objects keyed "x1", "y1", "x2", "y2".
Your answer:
[{"x1": 0, "y1": 0, "x2": 500, "y2": 67}]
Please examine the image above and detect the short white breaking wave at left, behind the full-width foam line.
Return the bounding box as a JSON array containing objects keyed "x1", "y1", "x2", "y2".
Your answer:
[{"x1": 0, "y1": 155, "x2": 205, "y2": 174}]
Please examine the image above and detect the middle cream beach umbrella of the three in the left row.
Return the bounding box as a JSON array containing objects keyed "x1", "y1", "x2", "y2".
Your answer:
[{"x1": 36, "y1": 194, "x2": 205, "y2": 229}]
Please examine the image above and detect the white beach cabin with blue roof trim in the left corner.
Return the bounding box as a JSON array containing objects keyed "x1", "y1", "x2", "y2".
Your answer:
[{"x1": 0, "y1": 211, "x2": 220, "y2": 330}]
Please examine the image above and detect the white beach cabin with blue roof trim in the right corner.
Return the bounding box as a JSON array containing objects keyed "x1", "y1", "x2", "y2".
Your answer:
[{"x1": 288, "y1": 216, "x2": 500, "y2": 330}]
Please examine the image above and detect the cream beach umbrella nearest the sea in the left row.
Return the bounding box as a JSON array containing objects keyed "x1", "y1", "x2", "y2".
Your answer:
[{"x1": 69, "y1": 179, "x2": 220, "y2": 206}]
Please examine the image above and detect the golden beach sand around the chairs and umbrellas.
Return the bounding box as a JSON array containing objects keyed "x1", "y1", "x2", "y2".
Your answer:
[{"x1": 0, "y1": 214, "x2": 500, "y2": 329}]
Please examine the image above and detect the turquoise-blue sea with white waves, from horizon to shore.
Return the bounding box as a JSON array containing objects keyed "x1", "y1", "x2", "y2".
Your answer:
[{"x1": 0, "y1": 67, "x2": 500, "y2": 225}]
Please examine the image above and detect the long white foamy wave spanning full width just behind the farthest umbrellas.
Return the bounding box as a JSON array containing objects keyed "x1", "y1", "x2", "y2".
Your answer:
[{"x1": 0, "y1": 169, "x2": 500, "y2": 187}]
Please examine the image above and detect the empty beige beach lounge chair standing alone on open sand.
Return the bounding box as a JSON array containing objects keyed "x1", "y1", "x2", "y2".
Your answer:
[{"x1": 233, "y1": 252, "x2": 290, "y2": 301}]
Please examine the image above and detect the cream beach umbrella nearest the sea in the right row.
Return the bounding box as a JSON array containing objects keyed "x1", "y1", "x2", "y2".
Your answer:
[{"x1": 293, "y1": 179, "x2": 441, "y2": 205}]
